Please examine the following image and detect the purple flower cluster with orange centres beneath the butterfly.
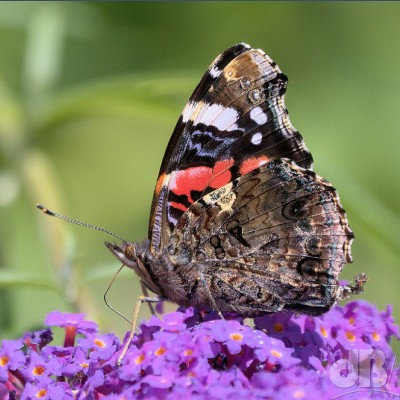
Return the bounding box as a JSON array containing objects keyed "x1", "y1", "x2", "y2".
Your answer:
[{"x1": 0, "y1": 301, "x2": 400, "y2": 400}]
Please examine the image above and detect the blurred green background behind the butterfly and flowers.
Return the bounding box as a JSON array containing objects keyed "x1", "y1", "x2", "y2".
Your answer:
[{"x1": 0, "y1": 2, "x2": 400, "y2": 338}]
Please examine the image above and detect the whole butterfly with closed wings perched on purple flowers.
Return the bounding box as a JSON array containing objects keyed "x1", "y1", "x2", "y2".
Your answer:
[{"x1": 106, "y1": 43, "x2": 365, "y2": 317}]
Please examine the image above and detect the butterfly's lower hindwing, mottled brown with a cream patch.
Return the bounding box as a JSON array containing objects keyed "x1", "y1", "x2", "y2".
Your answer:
[{"x1": 168, "y1": 159, "x2": 353, "y2": 316}]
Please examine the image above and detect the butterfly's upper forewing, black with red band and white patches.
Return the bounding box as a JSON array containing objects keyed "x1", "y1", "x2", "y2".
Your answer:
[{"x1": 149, "y1": 44, "x2": 312, "y2": 253}]
